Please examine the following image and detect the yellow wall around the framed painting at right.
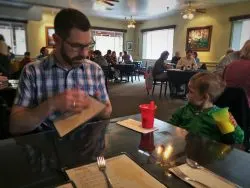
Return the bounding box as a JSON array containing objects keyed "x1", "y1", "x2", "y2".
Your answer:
[{"x1": 135, "y1": 2, "x2": 250, "y2": 63}]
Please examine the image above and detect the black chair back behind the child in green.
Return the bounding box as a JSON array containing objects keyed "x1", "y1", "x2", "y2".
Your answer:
[{"x1": 215, "y1": 87, "x2": 250, "y2": 151}]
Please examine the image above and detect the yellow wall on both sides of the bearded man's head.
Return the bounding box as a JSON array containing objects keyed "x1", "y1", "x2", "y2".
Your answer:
[{"x1": 27, "y1": 13, "x2": 129, "y2": 57}]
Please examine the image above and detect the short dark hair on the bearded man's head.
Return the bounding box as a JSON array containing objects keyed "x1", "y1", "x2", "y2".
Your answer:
[{"x1": 54, "y1": 8, "x2": 91, "y2": 39}]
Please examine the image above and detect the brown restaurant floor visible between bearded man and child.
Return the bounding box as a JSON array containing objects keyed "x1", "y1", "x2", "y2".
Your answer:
[{"x1": 109, "y1": 77, "x2": 185, "y2": 121}]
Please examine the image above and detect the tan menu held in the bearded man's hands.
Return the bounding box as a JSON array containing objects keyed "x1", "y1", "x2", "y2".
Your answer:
[{"x1": 54, "y1": 97, "x2": 105, "y2": 137}]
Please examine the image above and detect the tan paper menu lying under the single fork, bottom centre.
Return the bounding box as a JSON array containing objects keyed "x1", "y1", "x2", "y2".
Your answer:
[{"x1": 66, "y1": 155, "x2": 165, "y2": 188}]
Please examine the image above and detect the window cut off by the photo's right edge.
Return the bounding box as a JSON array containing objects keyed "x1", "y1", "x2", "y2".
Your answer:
[{"x1": 231, "y1": 19, "x2": 250, "y2": 50}]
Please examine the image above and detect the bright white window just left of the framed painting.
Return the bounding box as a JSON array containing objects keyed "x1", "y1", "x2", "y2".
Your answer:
[{"x1": 142, "y1": 28, "x2": 174, "y2": 59}]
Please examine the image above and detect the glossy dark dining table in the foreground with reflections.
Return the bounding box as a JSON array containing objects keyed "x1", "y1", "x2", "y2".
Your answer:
[{"x1": 0, "y1": 114, "x2": 250, "y2": 188}]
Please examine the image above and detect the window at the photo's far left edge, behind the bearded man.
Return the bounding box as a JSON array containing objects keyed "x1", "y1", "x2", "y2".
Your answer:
[{"x1": 0, "y1": 21, "x2": 27, "y2": 55}]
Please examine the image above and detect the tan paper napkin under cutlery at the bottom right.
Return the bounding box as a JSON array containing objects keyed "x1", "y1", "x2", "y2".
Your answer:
[{"x1": 169, "y1": 164, "x2": 237, "y2": 188}]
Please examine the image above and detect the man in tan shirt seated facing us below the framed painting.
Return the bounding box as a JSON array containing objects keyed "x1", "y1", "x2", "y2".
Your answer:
[{"x1": 176, "y1": 50, "x2": 198, "y2": 70}]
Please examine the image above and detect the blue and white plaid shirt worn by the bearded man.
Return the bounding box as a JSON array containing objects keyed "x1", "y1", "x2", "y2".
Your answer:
[{"x1": 14, "y1": 54, "x2": 109, "y2": 120}]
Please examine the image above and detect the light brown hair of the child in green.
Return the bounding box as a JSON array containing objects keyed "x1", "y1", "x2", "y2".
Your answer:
[{"x1": 190, "y1": 72, "x2": 226, "y2": 102}]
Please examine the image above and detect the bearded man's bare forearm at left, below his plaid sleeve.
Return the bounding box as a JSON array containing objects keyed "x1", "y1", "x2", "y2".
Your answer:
[{"x1": 10, "y1": 101, "x2": 53, "y2": 134}]
